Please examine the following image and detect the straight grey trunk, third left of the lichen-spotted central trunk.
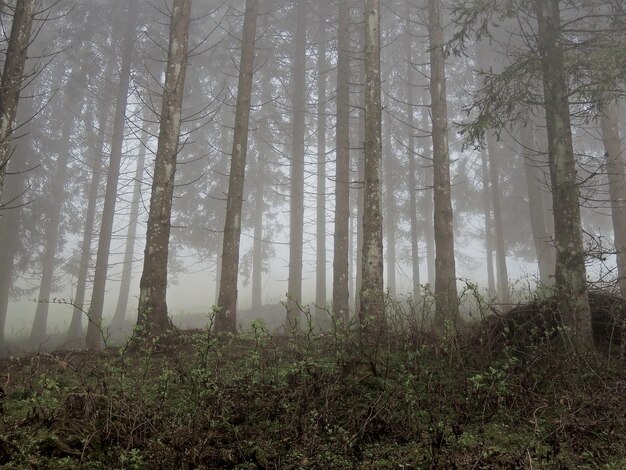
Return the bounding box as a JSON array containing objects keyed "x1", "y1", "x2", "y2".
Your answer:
[{"x1": 287, "y1": 0, "x2": 307, "y2": 330}]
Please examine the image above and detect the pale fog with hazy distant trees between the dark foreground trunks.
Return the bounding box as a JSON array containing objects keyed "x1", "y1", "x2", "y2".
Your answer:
[{"x1": 0, "y1": 0, "x2": 626, "y2": 349}]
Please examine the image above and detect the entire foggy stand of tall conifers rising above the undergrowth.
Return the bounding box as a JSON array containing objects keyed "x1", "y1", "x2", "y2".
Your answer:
[{"x1": 0, "y1": 0, "x2": 626, "y2": 351}]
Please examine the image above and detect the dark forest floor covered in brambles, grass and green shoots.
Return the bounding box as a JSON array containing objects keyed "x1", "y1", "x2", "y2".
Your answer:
[{"x1": 0, "y1": 308, "x2": 626, "y2": 469}]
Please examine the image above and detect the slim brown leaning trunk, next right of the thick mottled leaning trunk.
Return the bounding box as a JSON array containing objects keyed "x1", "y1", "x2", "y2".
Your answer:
[{"x1": 215, "y1": 0, "x2": 258, "y2": 332}]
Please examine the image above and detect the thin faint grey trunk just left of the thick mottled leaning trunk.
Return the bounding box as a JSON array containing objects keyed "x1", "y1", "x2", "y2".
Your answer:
[{"x1": 111, "y1": 121, "x2": 149, "y2": 334}]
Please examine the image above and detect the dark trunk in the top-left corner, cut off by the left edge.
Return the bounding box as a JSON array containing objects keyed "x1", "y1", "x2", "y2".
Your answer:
[{"x1": 0, "y1": 0, "x2": 35, "y2": 199}]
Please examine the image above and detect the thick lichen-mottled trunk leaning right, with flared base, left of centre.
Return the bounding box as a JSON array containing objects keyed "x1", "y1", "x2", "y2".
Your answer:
[{"x1": 137, "y1": 0, "x2": 191, "y2": 338}]
